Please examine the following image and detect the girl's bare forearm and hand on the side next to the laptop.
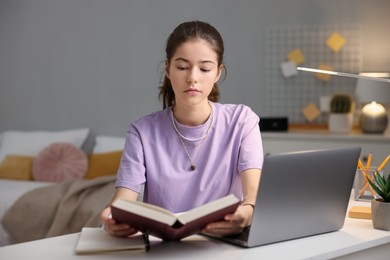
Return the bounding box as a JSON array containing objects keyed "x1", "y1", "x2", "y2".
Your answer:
[{"x1": 202, "y1": 169, "x2": 261, "y2": 235}]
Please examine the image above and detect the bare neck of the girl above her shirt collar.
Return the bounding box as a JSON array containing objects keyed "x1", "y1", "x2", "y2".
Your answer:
[{"x1": 173, "y1": 101, "x2": 211, "y2": 126}]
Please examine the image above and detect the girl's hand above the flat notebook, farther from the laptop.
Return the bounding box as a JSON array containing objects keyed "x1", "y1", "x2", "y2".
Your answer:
[{"x1": 100, "y1": 207, "x2": 138, "y2": 237}]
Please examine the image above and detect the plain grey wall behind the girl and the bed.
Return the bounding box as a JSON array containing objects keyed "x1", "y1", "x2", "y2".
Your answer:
[{"x1": 0, "y1": 0, "x2": 390, "y2": 135}]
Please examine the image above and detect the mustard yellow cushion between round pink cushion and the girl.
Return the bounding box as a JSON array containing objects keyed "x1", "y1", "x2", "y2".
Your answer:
[{"x1": 84, "y1": 151, "x2": 122, "y2": 179}]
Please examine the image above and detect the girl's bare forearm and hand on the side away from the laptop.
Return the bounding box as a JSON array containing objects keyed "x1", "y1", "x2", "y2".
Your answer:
[{"x1": 100, "y1": 187, "x2": 138, "y2": 237}]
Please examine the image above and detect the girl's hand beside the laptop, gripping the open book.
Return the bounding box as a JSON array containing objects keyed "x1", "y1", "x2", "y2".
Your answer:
[{"x1": 201, "y1": 205, "x2": 253, "y2": 236}]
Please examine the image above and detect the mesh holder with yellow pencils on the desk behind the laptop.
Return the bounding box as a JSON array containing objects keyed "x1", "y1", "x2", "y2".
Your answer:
[{"x1": 354, "y1": 167, "x2": 383, "y2": 201}]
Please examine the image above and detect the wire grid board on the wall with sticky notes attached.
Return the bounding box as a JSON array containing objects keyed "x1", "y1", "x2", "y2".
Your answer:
[{"x1": 262, "y1": 25, "x2": 362, "y2": 123}]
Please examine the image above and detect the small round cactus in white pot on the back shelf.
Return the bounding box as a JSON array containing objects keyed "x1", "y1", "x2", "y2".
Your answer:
[{"x1": 328, "y1": 94, "x2": 353, "y2": 133}]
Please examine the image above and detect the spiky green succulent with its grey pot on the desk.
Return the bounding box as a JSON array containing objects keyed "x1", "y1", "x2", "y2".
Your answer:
[{"x1": 365, "y1": 170, "x2": 390, "y2": 231}]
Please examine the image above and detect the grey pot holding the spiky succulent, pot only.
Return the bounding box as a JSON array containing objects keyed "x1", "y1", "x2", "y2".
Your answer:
[{"x1": 371, "y1": 199, "x2": 390, "y2": 231}]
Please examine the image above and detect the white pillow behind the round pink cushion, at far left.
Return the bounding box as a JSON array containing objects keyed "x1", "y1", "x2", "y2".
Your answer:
[{"x1": 0, "y1": 128, "x2": 89, "y2": 162}]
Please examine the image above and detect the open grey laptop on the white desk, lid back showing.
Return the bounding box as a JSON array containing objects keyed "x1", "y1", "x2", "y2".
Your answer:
[{"x1": 204, "y1": 147, "x2": 361, "y2": 247}]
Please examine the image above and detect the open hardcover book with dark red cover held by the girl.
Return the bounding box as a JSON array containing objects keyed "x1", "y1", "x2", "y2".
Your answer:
[{"x1": 111, "y1": 194, "x2": 240, "y2": 240}]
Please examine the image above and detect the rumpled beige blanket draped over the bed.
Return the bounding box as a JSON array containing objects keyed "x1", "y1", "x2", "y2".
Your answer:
[{"x1": 2, "y1": 176, "x2": 115, "y2": 243}]
